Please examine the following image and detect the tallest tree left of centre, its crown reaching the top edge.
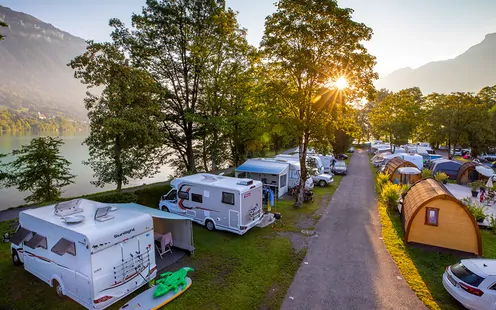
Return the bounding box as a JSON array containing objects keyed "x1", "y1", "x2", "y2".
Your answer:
[{"x1": 111, "y1": 0, "x2": 246, "y2": 173}]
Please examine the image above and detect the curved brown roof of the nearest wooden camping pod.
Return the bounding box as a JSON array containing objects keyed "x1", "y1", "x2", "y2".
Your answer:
[{"x1": 402, "y1": 178, "x2": 482, "y2": 256}]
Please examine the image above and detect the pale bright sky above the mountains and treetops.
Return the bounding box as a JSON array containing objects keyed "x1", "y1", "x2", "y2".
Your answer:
[{"x1": 0, "y1": 0, "x2": 496, "y2": 77}]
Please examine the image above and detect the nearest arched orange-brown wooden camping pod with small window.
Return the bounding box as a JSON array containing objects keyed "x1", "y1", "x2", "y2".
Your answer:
[{"x1": 401, "y1": 179, "x2": 482, "y2": 256}]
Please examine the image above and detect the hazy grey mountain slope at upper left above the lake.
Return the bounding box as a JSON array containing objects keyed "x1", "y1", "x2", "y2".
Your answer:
[{"x1": 0, "y1": 5, "x2": 86, "y2": 118}]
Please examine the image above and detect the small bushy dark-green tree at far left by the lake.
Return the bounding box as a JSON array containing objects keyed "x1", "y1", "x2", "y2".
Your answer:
[{"x1": 9, "y1": 137, "x2": 75, "y2": 203}]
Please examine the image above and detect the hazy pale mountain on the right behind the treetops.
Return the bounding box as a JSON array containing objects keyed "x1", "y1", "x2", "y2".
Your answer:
[{"x1": 376, "y1": 33, "x2": 496, "y2": 94}]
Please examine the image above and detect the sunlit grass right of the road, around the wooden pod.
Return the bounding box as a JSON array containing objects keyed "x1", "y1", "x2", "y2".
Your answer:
[{"x1": 371, "y1": 159, "x2": 496, "y2": 309}]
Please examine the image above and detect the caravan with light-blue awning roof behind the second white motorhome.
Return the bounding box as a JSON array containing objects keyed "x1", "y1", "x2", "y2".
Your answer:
[{"x1": 235, "y1": 158, "x2": 290, "y2": 197}]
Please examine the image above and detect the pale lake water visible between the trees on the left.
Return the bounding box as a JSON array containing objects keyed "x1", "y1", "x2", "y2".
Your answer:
[{"x1": 0, "y1": 132, "x2": 172, "y2": 210}]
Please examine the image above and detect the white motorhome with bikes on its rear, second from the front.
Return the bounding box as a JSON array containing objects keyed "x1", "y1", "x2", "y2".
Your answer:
[{"x1": 159, "y1": 173, "x2": 263, "y2": 235}]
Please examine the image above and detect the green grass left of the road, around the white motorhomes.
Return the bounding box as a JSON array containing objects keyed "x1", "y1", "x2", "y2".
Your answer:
[{"x1": 0, "y1": 160, "x2": 349, "y2": 310}]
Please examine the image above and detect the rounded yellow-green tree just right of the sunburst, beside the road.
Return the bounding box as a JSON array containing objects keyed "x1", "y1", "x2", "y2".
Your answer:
[{"x1": 369, "y1": 87, "x2": 424, "y2": 153}]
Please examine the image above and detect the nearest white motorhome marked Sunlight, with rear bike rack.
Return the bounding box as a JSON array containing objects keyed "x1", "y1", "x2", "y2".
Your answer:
[{"x1": 11, "y1": 199, "x2": 157, "y2": 309}]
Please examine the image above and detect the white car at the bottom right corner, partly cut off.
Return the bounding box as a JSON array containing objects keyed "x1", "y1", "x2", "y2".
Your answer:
[{"x1": 443, "y1": 258, "x2": 496, "y2": 310}]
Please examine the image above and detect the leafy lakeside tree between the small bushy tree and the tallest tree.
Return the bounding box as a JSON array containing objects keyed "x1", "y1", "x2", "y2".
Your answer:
[{"x1": 69, "y1": 41, "x2": 163, "y2": 191}]
